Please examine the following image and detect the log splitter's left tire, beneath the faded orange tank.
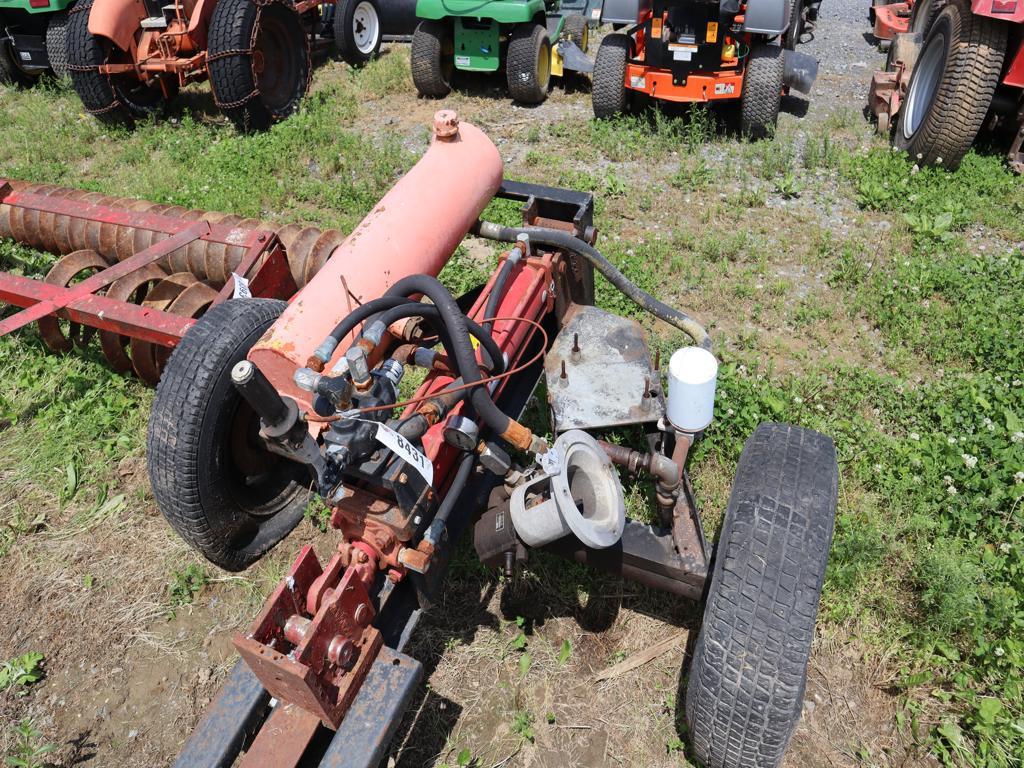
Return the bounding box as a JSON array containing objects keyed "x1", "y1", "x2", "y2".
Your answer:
[{"x1": 146, "y1": 299, "x2": 308, "y2": 570}]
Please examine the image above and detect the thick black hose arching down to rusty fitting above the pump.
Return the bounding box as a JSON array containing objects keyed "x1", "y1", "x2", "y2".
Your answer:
[{"x1": 385, "y1": 274, "x2": 520, "y2": 446}]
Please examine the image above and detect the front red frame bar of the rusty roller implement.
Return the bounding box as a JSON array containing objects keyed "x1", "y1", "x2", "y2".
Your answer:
[{"x1": 0, "y1": 272, "x2": 196, "y2": 347}]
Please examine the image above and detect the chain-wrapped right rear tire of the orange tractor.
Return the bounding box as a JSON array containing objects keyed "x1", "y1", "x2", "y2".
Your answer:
[{"x1": 209, "y1": 0, "x2": 312, "y2": 133}]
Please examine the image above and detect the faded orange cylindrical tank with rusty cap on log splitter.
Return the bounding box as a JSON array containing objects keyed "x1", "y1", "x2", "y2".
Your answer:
[{"x1": 249, "y1": 110, "x2": 502, "y2": 401}]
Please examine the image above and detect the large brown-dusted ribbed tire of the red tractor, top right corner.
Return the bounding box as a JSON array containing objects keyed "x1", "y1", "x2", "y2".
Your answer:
[{"x1": 893, "y1": 0, "x2": 1008, "y2": 170}]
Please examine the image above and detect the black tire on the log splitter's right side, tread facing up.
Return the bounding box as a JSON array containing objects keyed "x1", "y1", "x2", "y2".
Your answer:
[{"x1": 686, "y1": 424, "x2": 839, "y2": 768}]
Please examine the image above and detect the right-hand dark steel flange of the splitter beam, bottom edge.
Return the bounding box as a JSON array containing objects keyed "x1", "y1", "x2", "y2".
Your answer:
[{"x1": 319, "y1": 648, "x2": 423, "y2": 768}]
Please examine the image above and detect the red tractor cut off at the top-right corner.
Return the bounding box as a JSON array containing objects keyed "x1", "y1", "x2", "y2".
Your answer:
[{"x1": 869, "y1": 0, "x2": 1024, "y2": 172}]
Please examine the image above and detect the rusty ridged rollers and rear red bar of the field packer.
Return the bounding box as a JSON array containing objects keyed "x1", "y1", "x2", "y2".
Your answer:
[{"x1": 0, "y1": 181, "x2": 345, "y2": 384}]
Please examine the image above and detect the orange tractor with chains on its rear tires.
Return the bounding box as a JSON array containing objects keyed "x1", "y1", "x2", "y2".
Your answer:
[{"x1": 68, "y1": 0, "x2": 412, "y2": 131}]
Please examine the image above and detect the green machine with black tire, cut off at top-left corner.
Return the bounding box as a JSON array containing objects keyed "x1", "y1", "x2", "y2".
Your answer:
[{"x1": 0, "y1": 0, "x2": 75, "y2": 85}]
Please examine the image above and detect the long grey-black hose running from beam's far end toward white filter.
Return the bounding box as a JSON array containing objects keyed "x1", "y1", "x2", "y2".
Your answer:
[{"x1": 472, "y1": 221, "x2": 712, "y2": 351}]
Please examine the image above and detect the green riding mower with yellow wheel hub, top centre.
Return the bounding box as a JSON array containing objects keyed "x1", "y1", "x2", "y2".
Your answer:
[{"x1": 412, "y1": 0, "x2": 600, "y2": 104}]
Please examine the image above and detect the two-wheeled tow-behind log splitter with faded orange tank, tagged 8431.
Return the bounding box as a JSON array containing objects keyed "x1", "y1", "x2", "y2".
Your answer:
[{"x1": 0, "y1": 112, "x2": 838, "y2": 768}]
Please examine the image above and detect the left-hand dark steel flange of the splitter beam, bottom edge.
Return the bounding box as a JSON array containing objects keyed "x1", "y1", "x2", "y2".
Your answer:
[{"x1": 173, "y1": 660, "x2": 270, "y2": 768}]
